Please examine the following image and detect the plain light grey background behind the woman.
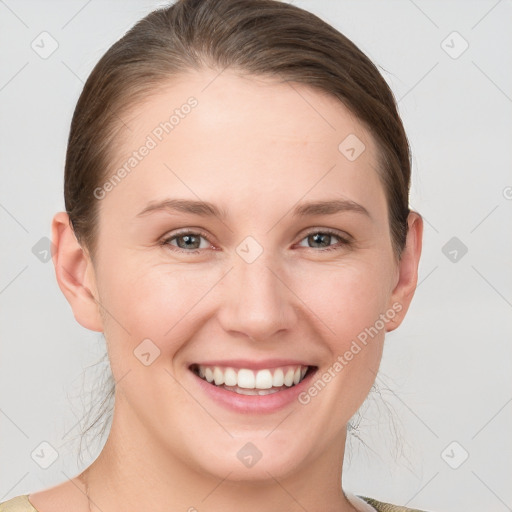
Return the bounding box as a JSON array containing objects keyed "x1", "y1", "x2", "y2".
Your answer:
[{"x1": 0, "y1": 0, "x2": 512, "y2": 512}]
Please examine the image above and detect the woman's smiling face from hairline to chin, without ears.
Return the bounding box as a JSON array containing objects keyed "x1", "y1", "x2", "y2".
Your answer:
[{"x1": 79, "y1": 71, "x2": 404, "y2": 479}]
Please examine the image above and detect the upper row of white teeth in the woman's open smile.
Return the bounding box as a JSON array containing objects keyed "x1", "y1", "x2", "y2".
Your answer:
[{"x1": 197, "y1": 365, "x2": 308, "y2": 395}]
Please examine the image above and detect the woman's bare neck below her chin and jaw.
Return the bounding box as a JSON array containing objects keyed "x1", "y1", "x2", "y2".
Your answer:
[{"x1": 83, "y1": 400, "x2": 355, "y2": 512}]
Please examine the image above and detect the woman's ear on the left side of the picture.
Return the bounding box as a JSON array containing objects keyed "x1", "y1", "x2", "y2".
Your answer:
[{"x1": 52, "y1": 212, "x2": 103, "y2": 332}]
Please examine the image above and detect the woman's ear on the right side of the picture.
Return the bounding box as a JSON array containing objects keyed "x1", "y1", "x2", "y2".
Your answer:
[{"x1": 386, "y1": 211, "x2": 423, "y2": 332}]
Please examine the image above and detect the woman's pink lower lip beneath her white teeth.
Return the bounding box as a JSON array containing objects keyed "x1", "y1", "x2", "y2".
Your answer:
[{"x1": 189, "y1": 370, "x2": 316, "y2": 414}]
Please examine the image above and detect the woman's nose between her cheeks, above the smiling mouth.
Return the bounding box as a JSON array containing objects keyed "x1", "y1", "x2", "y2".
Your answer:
[{"x1": 218, "y1": 255, "x2": 298, "y2": 342}]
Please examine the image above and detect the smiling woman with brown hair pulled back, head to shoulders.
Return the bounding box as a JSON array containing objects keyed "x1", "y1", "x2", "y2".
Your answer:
[{"x1": 0, "y1": 0, "x2": 423, "y2": 512}]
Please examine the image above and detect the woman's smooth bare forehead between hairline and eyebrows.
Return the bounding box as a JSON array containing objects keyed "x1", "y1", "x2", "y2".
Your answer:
[{"x1": 102, "y1": 70, "x2": 385, "y2": 224}]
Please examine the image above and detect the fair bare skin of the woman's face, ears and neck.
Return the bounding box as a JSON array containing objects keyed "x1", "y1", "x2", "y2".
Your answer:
[{"x1": 30, "y1": 70, "x2": 423, "y2": 512}]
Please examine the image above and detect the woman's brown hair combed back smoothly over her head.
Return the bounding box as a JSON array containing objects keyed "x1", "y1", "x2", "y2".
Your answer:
[{"x1": 64, "y1": 0, "x2": 411, "y2": 464}]
